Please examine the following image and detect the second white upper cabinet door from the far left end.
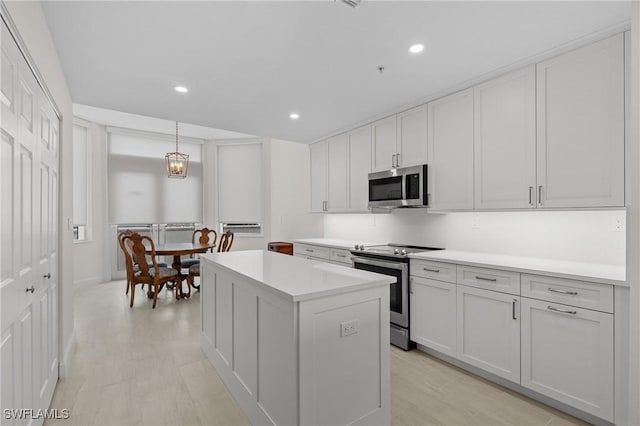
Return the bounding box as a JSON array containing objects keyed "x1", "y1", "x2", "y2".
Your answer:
[{"x1": 326, "y1": 133, "x2": 349, "y2": 211}]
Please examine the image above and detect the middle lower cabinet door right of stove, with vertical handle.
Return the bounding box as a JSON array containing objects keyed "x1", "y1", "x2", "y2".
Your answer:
[{"x1": 457, "y1": 285, "x2": 520, "y2": 383}]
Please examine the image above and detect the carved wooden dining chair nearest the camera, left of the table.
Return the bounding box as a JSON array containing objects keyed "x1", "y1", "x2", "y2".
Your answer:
[{"x1": 122, "y1": 232, "x2": 178, "y2": 309}]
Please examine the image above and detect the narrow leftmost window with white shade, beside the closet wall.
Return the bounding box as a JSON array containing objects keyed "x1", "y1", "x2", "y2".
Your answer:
[{"x1": 73, "y1": 119, "x2": 91, "y2": 241}]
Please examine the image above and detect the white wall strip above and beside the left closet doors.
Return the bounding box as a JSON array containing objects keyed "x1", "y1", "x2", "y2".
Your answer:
[{"x1": 4, "y1": 1, "x2": 74, "y2": 375}]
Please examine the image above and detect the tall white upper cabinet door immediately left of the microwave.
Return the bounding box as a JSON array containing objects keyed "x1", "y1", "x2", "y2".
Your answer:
[{"x1": 347, "y1": 126, "x2": 371, "y2": 212}]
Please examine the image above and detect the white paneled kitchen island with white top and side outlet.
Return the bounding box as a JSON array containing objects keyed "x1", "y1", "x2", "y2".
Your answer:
[{"x1": 200, "y1": 250, "x2": 391, "y2": 425}]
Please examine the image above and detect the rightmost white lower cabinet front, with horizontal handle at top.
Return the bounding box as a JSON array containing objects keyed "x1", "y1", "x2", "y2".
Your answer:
[{"x1": 522, "y1": 298, "x2": 614, "y2": 421}]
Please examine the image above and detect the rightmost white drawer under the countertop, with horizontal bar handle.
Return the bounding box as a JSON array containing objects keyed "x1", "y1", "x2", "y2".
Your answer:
[{"x1": 522, "y1": 274, "x2": 613, "y2": 313}]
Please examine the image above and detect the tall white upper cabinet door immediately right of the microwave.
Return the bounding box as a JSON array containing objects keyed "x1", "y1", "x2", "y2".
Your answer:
[{"x1": 427, "y1": 89, "x2": 473, "y2": 210}]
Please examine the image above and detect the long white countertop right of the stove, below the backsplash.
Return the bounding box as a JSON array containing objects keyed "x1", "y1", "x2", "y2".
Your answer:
[{"x1": 409, "y1": 250, "x2": 628, "y2": 286}]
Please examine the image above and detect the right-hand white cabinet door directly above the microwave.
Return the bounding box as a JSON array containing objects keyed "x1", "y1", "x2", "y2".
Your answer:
[{"x1": 396, "y1": 105, "x2": 427, "y2": 167}]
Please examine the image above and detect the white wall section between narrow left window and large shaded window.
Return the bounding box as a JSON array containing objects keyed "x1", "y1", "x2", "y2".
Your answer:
[{"x1": 73, "y1": 122, "x2": 110, "y2": 286}]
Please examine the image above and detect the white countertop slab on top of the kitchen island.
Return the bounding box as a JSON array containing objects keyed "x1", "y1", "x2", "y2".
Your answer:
[{"x1": 200, "y1": 250, "x2": 395, "y2": 302}]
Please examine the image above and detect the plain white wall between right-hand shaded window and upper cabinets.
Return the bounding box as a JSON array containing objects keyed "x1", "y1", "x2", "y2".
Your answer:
[{"x1": 270, "y1": 140, "x2": 323, "y2": 242}]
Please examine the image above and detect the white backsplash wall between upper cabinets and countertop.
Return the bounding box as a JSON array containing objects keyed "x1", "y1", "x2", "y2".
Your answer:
[{"x1": 324, "y1": 209, "x2": 625, "y2": 265}]
